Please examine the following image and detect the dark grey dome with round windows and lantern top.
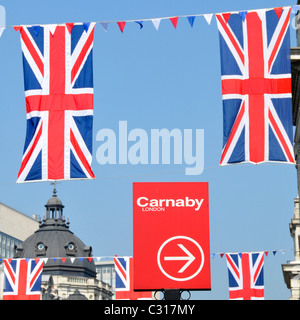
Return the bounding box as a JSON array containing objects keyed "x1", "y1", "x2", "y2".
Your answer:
[{"x1": 14, "y1": 188, "x2": 96, "y2": 278}]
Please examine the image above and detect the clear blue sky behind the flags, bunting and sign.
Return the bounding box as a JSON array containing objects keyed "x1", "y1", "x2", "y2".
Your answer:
[{"x1": 0, "y1": 0, "x2": 297, "y2": 299}]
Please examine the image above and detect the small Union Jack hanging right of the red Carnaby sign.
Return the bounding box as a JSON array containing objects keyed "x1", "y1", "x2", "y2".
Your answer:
[{"x1": 226, "y1": 252, "x2": 264, "y2": 300}]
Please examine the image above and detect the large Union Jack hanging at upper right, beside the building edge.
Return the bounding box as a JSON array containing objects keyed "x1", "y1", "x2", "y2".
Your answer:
[{"x1": 216, "y1": 7, "x2": 295, "y2": 165}]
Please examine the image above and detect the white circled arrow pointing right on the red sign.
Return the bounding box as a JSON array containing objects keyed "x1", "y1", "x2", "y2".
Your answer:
[{"x1": 157, "y1": 236, "x2": 204, "y2": 281}]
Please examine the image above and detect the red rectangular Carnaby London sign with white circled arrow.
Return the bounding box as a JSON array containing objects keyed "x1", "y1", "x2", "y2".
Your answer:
[{"x1": 133, "y1": 182, "x2": 211, "y2": 290}]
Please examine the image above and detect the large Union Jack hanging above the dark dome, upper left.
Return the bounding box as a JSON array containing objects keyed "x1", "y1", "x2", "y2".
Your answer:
[{"x1": 15, "y1": 23, "x2": 95, "y2": 182}]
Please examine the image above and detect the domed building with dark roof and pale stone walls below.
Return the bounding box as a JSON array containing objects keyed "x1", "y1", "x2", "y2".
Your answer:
[{"x1": 14, "y1": 189, "x2": 113, "y2": 300}]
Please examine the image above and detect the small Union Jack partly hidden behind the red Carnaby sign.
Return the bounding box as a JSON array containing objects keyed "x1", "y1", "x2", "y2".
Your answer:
[{"x1": 114, "y1": 257, "x2": 152, "y2": 300}]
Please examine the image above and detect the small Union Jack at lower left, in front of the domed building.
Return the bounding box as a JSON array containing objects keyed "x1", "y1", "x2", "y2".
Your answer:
[{"x1": 3, "y1": 259, "x2": 44, "y2": 300}]
